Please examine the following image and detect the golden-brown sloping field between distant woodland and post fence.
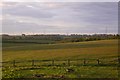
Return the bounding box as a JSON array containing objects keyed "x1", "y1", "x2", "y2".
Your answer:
[{"x1": 2, "y1": 40, "x2": 118, "y2": 61}]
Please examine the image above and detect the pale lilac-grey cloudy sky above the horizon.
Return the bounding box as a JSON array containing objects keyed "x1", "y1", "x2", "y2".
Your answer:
[{"x1": 0, "y1": 2, "x2": 118, "y2": 34}]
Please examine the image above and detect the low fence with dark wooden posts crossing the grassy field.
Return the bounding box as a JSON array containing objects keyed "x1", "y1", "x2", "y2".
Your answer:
[{"x1": 1, "y1": 58, "x2": 119, "y2": 67}]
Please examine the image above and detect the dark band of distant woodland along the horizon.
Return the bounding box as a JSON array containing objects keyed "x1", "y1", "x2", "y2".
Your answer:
[{"x1": 1, "y1": 34, "x2": 120, "y2": 44}]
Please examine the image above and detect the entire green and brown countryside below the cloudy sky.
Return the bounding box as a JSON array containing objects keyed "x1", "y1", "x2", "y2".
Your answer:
[{"x1": 2, "y1": 34, "x2": 119, "y2": 79}]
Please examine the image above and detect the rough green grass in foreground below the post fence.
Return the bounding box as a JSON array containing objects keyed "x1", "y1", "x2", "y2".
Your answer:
[{"x1": 3, "y1": 66, "x2": 118, "y2": 78}]
